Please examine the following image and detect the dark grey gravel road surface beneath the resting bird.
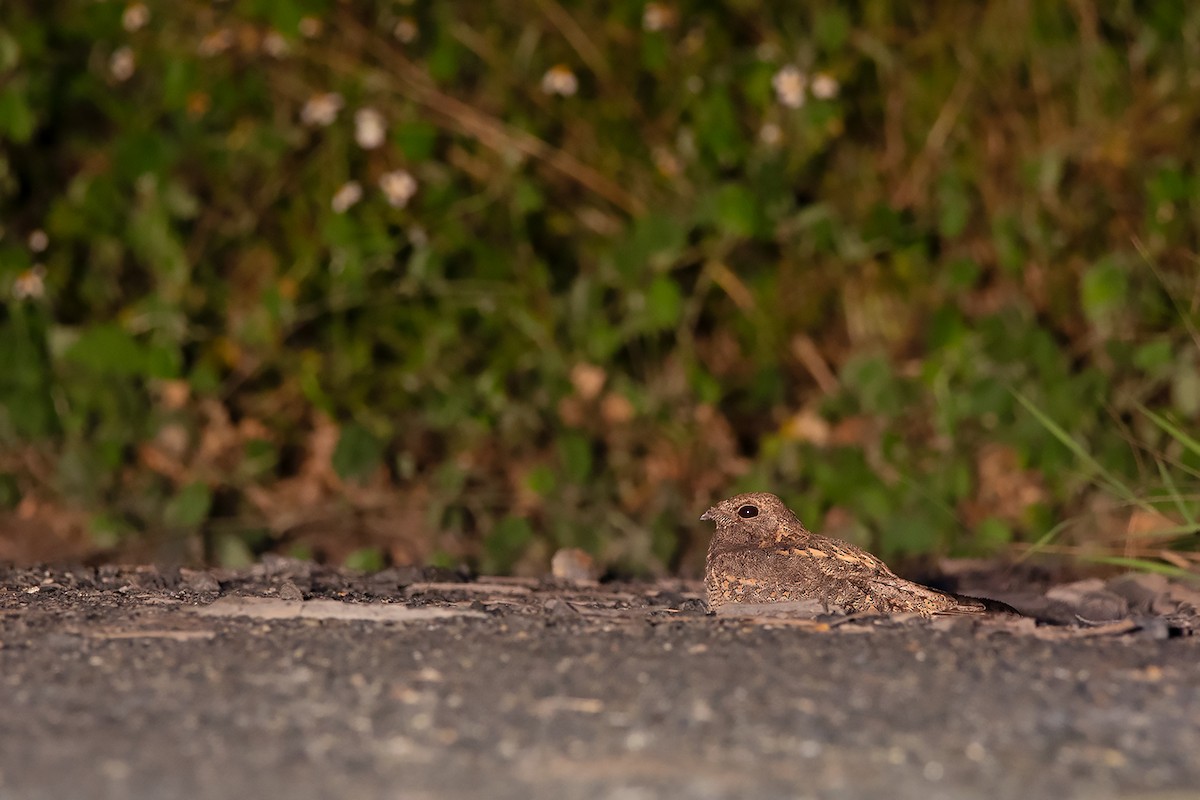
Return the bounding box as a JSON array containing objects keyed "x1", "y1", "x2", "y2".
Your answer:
[{"x1": 0, "y1": 560, "x2": 1200, "y2": 800}]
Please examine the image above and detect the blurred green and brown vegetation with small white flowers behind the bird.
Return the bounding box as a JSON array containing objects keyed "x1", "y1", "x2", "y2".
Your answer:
[{"x1": 0, "y1": 0, "x2": 1200, "y2": 572}]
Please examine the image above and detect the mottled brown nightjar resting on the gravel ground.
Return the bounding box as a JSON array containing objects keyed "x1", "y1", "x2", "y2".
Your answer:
[{"x1": 701, "y1": 492, "x2": 1007, "y2": 616}]
